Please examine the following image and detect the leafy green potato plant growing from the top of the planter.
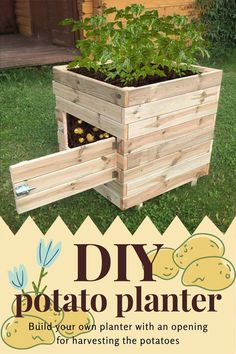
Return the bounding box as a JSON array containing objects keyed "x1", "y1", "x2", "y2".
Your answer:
[{"x1": 62, "y1": 4, "x2": 208, "y2": 84}]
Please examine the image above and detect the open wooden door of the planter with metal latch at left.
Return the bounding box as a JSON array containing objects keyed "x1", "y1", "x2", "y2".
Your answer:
[{"x1": 10, "y1": 138, "x2": 116, "y2": 213}]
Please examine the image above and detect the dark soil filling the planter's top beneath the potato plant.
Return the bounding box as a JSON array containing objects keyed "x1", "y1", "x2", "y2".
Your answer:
[{"x1": 69, "y1": 67, "x2": 196, "y2": 87}]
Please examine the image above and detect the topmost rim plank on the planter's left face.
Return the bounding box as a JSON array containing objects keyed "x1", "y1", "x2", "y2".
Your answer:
[{"x1": 53, "y1": 65, "x2": 126, "y2": 107}]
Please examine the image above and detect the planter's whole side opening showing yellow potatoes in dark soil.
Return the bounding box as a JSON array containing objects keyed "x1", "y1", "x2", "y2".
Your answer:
[{"x1": 66, "y1": 114, "x2": 112, "y2": 148}]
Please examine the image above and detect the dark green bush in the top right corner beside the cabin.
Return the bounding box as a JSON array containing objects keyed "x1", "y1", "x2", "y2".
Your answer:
[{"x1": 197, "y1": 0, "x2": 236, "y2": 50}]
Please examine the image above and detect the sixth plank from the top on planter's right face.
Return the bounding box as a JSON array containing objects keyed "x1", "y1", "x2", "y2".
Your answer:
[{"x1": 119, "y1": 140, "x2": 212, "y2": 183}]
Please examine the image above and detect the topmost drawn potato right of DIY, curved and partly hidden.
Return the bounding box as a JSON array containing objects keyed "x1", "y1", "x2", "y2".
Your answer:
[{"x1": 173, "y1": 233, "x2": 225, "y2": 269}]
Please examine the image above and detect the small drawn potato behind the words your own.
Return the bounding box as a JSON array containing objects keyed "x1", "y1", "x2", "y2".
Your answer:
[{"x1": 59, "y1": 308, "x2": 94, "y2": 338}]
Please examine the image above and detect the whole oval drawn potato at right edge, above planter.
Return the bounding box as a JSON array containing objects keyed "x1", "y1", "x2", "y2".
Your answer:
[{"x1": 182, "y1": 257, "x2": 235, "y2": 291}]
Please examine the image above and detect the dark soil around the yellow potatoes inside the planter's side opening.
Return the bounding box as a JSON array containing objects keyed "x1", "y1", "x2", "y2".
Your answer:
[{"x1": 67, "y1": 114, "x2": 112, "y2": 148}]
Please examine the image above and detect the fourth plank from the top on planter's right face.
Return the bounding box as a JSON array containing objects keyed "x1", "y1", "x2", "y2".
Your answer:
[{"x1": 118, "y1": 114, "x2": 215, "y2": 154}]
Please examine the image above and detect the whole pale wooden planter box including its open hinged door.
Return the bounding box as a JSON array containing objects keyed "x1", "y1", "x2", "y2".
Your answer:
[{"x1": 10, "y1": 66, "x2": 222, "y2": 213}]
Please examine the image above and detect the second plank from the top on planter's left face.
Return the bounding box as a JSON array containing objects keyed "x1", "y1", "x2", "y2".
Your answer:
[{"x1": 53, "y1": 81, "x2": 122, "y2": 123}]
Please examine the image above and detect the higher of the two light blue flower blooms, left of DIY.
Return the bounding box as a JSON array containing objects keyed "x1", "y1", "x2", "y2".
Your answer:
[{"x1": 37, "y1": 240, "x2": 61, "y2": 268}]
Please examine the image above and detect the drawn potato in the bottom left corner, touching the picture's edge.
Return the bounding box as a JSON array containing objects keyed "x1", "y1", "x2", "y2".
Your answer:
[{"x1": 1, "y1": 316, "x2": 55, "y2": 349}]
